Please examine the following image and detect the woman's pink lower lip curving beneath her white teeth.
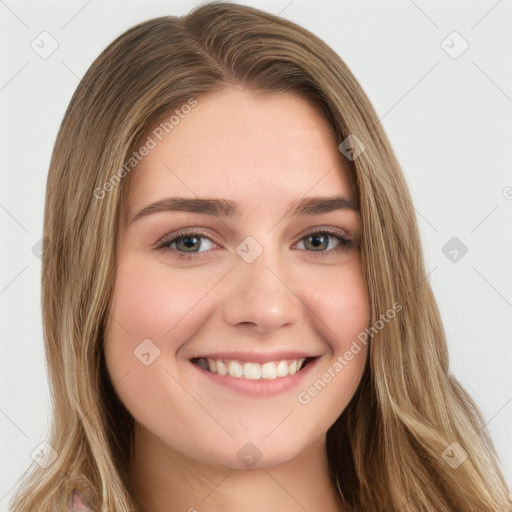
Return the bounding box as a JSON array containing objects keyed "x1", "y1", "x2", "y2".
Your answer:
[{"x1": 190, "y1": 357, "x2": 319, "y2": 397}]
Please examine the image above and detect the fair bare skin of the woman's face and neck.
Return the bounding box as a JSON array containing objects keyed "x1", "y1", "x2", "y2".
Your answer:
[{"x1": 105, "y1": 86, "x2": 369, "y2": 512}]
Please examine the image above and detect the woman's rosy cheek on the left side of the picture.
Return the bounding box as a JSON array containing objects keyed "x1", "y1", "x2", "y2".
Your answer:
[{"x1": 105, "y1": 258, "x2": 211, "y2": 402}]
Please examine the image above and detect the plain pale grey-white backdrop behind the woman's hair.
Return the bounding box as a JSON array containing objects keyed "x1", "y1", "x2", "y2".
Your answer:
[{"x1": 0, "y1": 0, "x2": 512, "y2": 511}]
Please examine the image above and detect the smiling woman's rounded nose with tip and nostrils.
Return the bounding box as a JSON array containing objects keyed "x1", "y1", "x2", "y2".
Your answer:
[{"x1": 222, "y1": 245, "x2": 304, "y2": 334}]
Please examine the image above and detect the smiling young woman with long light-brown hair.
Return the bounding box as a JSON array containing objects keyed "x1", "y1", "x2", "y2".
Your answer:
[{"x1": 9, "y1": 3, "x2": 512, "y2": 512}]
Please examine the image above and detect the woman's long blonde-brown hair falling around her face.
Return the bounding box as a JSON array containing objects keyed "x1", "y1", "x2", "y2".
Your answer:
[{"x1": 12, "y1": 2, "x2": 512, "y2": 512}]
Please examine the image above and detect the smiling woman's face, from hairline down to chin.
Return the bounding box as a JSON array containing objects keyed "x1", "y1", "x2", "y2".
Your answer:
[{"x1": 104, "y1": 87, "x2": 369, "y2": 468}]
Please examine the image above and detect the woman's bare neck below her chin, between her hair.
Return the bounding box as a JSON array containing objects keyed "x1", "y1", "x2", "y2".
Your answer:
[{"x1": 129, "y1": 426, "x2": 343, "y2": 512}]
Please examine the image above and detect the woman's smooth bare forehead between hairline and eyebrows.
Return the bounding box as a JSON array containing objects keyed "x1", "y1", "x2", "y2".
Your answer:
[{"x1": 127, "y1": 87, "x2": 351, "y2": 215}]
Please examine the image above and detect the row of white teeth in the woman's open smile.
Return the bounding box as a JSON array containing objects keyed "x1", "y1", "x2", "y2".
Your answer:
[{"x1": 196, "y1": 357, "x2": 306, "y2": 380}]
